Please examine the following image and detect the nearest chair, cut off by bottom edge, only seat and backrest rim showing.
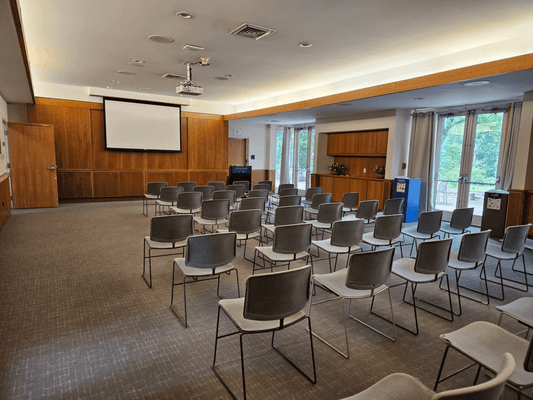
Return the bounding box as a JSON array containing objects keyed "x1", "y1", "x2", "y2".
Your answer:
[{"x1": 344, "y1": 353, "x2": 516, "y2": 400}]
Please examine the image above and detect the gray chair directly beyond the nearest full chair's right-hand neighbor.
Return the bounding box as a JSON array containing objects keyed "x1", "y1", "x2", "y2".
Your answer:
[{"x1": 312, "y1": 219, "x2": 365, "y2": 272}]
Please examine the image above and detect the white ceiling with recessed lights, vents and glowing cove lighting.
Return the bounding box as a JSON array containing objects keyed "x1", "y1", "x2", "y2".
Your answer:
[{"x1": 0, "y1": 0, "x2": 533, "y2": 122}]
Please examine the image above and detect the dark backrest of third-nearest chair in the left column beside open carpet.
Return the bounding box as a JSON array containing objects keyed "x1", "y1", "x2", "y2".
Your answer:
[{"x1": 150, "y1": 214, "x2": 194, "y2": 243}]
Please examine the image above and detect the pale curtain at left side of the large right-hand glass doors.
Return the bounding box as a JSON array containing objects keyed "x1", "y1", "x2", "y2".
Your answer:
[{"x1": 407, "y1": 112, "x2": 438, "y2": 212}]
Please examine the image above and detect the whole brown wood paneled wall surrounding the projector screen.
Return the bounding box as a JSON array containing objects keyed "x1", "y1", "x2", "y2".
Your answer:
[{"x1": 28, "y1": 98, "x2": 228, "y2": 202}]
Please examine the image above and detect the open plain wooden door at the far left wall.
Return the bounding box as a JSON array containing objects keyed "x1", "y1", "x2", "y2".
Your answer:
[{"x1": 8, "y1": 123, "x2": 59, "y2": 208}]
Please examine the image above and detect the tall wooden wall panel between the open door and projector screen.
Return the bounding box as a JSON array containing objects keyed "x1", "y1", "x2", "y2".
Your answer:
[{"x1": 28, "y1": 104, "x2": 93, "y2": 169}]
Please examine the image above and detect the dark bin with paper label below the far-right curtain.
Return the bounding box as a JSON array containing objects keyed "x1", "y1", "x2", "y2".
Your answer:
[{"x1": 481, "y1": 189, "x2": 509, "y2": 239}]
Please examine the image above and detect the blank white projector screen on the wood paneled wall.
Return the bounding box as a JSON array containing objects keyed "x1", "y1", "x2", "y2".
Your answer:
[{"x1": 104, "y1": 98, "x2": 181, "y2": 152}]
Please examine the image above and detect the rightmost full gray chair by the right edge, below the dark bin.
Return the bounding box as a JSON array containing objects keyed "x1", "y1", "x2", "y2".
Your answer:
[{"x1": 483, "y1": 224, "x2": 531, "y2": 300}]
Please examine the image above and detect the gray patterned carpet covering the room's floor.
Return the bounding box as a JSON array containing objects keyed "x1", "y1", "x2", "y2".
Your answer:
[{"x1": 0, "y1": 202, "x2": 533, "y2": 399}]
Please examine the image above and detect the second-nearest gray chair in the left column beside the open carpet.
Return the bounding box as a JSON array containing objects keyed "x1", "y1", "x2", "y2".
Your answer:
[{"x1": 170, "y1": 231, "x2": 241, "y2": 328}]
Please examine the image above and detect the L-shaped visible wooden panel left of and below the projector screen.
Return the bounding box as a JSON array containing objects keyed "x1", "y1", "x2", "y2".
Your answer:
[{"x1": 90, "y1": 110, "x2": 144, "y2": 171}]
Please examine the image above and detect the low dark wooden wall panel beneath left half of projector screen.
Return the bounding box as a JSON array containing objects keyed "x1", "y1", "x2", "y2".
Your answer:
[{"x1": 93, "y1": 171, "x2": 145, "y2": 197}]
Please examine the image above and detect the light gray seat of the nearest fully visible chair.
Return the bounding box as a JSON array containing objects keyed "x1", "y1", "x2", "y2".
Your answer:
[{"x1": 218, "y1": 297, "x2": 305, "y2": 333}]
